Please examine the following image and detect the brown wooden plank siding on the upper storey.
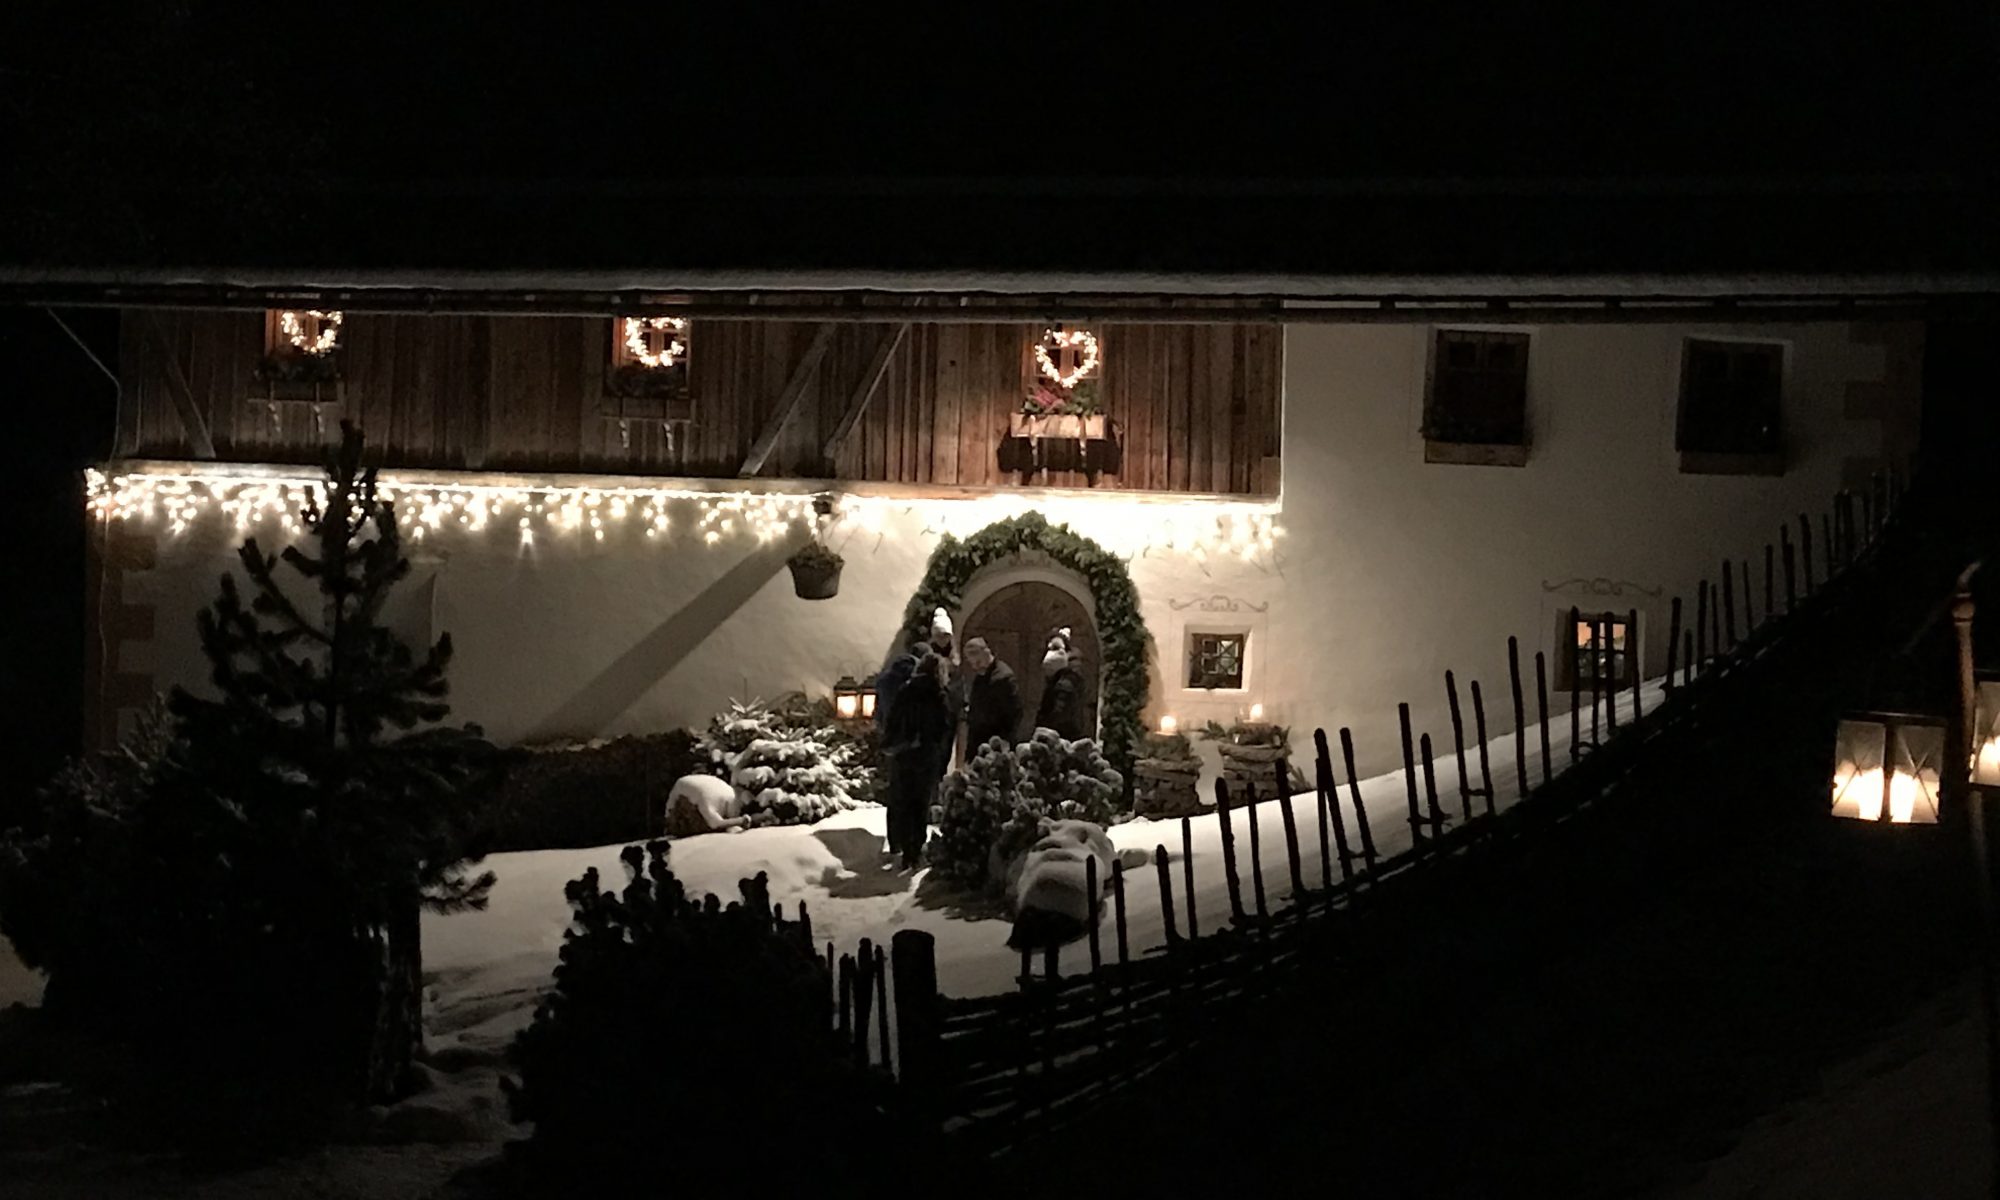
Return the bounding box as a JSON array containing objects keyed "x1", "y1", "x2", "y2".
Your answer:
[{"x1": 116, "y1": 310, "x2": 1284, "y2": 496}]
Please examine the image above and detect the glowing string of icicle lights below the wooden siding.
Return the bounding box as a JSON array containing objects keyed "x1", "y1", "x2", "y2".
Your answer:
[{"x1": 86, "y1": 470, "x2": 1284, "y2": 560}]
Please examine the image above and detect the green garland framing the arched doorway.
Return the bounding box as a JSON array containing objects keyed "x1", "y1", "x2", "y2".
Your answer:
[{"x1": 902, "y1": 512, "x2": 1152, "y2": 796}]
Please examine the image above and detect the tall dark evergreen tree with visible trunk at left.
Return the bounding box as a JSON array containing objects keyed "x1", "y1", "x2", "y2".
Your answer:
[{"x1": 166, "y1": 422, "x2": 494, "y2": 1098}]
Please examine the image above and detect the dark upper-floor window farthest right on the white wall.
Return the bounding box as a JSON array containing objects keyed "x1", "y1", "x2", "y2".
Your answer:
[{"x1": 1674, "y1": 338, "x2": 1784, "y2": 474}]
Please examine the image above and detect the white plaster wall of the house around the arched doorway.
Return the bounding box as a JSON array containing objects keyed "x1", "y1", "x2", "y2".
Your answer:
[{"x1": 105, "y1": 326, "x2": 1914, "y2": 770}]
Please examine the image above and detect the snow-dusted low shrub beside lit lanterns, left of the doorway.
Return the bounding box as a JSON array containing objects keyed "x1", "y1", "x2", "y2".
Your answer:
[{"x1": 702, "y1": 700, "x2": 874, "y2": 824}]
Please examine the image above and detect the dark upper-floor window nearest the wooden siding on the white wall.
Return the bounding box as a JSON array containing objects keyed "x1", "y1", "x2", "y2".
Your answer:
[{"x1": 1424, "y1": 330, "x2": 1528, "y2": 466}]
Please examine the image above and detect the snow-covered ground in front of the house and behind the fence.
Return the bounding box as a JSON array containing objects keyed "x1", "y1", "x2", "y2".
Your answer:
[{"x1": 424, "y1": 682, "x2": 1662, "y2": 1056}]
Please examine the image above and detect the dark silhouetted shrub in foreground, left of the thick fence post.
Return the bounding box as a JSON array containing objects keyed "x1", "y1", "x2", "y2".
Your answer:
[{"x1": 510, "y1": 842, "x2": 896, "y2": 1194}]
